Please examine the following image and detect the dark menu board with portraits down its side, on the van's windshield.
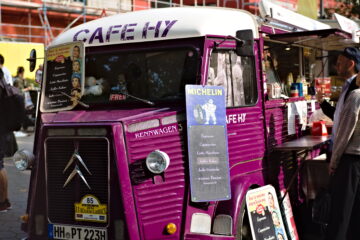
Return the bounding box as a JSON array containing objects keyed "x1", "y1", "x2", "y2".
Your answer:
[{"x1": 40, "y1": 42, "x2": 85, "y2": 112}]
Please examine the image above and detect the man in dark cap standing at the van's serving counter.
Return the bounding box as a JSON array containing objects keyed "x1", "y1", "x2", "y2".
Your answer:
[{"x1": 316, "y1": 47, "x2": 360, "y2": 147}]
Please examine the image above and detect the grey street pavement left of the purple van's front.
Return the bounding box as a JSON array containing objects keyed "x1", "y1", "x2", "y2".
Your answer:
[{"x1": 0, "y1": 133, "x2": 34, "y2": 240}]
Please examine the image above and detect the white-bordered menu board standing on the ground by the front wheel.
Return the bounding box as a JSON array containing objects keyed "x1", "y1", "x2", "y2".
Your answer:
[{"x1": 246, "y1": 185, "x2": 288, "y2": 240}]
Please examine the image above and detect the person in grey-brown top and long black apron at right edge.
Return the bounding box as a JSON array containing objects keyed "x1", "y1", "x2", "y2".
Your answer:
[{"x1": 325, "y1": 69, "x2": 360, "y2": 240}]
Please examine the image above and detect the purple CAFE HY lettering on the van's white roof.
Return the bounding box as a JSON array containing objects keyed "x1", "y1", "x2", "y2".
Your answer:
[{"x1": 73, "y1": 20, "x2": 177, "y2": 44}]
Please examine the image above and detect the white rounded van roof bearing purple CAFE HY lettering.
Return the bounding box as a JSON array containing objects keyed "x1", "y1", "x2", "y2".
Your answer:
[{"x1": 51, "y1": 7, "x2": 259, "y2": 46}]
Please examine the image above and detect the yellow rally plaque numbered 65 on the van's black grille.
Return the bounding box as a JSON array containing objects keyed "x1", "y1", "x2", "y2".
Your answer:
[{"x1": 74, "y1": 194, "x2": 107, "y2": 222}]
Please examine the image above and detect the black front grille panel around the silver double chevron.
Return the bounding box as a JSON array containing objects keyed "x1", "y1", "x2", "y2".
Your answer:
[{"x1": 45, "y1": 138, "x2": 110, "y2": 226}]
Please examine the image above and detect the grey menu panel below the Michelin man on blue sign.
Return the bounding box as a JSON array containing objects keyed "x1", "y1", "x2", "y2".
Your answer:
[{"x1": 188, "y1": 125, "x2": 231, "y2": 202}]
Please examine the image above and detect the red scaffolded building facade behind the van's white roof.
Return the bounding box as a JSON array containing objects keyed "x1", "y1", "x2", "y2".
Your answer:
[{"x1": 0, "y1": 0, "x2": 306, "y2": 45}]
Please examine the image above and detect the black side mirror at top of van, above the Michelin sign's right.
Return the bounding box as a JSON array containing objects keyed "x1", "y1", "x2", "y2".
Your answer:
[{"x1": 236, "y1": 30, "x2": 254, "y2": 56}]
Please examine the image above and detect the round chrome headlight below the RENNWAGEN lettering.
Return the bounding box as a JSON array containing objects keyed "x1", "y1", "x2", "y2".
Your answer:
[{"x1": 146, "y1": 150, "x2": 170, "y2": 174}]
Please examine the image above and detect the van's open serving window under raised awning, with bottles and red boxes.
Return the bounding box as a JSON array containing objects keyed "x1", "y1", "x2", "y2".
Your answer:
[{"x1": 263, "y1": 29, "x2": 358, "y2": 100}]
